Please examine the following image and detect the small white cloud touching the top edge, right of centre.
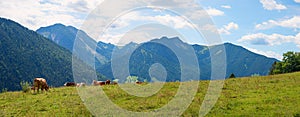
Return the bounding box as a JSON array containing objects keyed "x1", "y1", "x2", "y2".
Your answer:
[{"x1": 260, "y1": 0, "x2": 287, "y2": 10}]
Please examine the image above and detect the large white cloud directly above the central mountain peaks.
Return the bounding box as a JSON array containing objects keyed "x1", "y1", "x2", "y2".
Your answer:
[{"x1": 95, "y1": 11, "x2": 192, "y2": 45}]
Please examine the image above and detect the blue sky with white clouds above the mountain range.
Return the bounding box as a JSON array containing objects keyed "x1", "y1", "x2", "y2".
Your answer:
[{"x1": 0, "y1": 0, "x2": 300, "y2": 60}]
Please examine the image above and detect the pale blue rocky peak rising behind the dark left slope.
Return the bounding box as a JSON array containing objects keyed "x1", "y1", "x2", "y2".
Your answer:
[{"x1": 36, "y1": 23, "x2": 111, "y2": 64}]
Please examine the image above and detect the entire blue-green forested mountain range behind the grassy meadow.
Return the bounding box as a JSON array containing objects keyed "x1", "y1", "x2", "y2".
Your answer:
[{"x1": 0, "y1": 18, "x2": 278, "y2": 90}]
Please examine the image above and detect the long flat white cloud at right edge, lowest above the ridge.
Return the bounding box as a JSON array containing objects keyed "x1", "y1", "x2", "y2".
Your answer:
[{"x1": 238, "y1": 33, "x2": 300, "y2": 48}]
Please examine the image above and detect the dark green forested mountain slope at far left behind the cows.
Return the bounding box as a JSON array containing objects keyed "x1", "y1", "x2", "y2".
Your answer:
[{"x1": 0, "y1": 18, "x2": 105, "y2": 90}]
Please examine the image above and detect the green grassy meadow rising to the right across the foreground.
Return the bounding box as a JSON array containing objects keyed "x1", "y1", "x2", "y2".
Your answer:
[{"x1": 0, "y1": 72, "x2": 300, "y2": 116}]
